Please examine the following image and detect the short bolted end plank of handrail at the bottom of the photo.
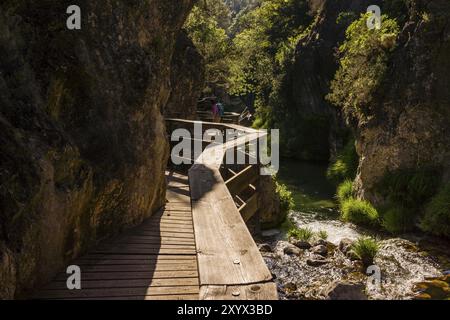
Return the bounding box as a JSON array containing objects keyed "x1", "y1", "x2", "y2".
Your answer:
[{"x1": 199, "y1": 282, "x2": 278, "y2": 300}]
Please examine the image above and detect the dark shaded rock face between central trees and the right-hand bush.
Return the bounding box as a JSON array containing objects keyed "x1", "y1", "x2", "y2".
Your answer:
[{"x1": 280, "y1": 0, "x2": 380, "y2": 161}]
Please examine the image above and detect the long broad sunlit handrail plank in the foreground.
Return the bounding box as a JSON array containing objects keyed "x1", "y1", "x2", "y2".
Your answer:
[{"x1": 189, "y1": 169, "x2": 272, "y2": 285}]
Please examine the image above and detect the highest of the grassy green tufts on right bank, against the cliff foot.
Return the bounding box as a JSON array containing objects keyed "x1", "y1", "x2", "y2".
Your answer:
[{"x1": 327, "y1": 140, "x2": 359, "y2": 183}]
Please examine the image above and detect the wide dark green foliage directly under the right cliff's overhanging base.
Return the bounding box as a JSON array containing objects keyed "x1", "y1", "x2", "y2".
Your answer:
[{"x1": 377, "y1": 168, "x2": 440, "y2": 209}]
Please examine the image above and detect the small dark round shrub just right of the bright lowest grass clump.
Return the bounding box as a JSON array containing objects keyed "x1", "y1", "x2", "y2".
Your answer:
[{"x1": 382, "y1": 206, "x2": 416, "y2": 234}]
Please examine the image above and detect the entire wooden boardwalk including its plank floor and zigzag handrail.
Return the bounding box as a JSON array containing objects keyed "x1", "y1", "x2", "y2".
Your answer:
[{"x1": 35, "y1": 119, "x2": 278, "y2": 300}]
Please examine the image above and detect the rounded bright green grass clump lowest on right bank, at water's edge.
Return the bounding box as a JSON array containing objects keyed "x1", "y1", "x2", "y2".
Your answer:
[{"x1": 341, "y1": 198, "x2": 378, "y2": 226}]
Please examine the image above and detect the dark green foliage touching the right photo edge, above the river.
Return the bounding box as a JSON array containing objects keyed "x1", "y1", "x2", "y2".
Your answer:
[{"x1": 420, "y1": 183, "x2": 450, "y2": 238}]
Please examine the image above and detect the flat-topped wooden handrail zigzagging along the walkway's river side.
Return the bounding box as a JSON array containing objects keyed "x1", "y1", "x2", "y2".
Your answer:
[{"x1": 167, "y1": 119, "x2": 278, "y2": 299}]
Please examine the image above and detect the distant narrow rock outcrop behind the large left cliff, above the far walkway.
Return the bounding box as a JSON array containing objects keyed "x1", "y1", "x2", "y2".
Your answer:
[{"x1": 164, "y1": 32, "x2": 205, "y2": 120}]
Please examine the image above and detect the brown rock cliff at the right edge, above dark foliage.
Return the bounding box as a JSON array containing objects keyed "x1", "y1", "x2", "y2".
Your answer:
[{"x1": 356, "y1": 0, "x2": 450, "y2": 204}]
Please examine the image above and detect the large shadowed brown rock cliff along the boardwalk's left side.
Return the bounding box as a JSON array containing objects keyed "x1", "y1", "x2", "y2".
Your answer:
[{"x1": 0, "y1": 0, "x2": 194, "y2": 298}]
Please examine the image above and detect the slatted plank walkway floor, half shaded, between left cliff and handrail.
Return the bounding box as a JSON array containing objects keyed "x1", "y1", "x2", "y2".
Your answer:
[{"x1": 36, "y1": 172, "x2": 199, "y2": 300}]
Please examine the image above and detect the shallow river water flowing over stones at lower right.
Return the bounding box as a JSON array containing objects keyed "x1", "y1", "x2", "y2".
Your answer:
[{"x1": 259, "y1": 160, "x2": 450, "y2": 299}]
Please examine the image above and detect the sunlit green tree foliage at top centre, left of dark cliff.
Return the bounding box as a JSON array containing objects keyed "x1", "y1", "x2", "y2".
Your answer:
[{"x1": 230, "y1": 0, "x2": 311, "y2": 95}]
